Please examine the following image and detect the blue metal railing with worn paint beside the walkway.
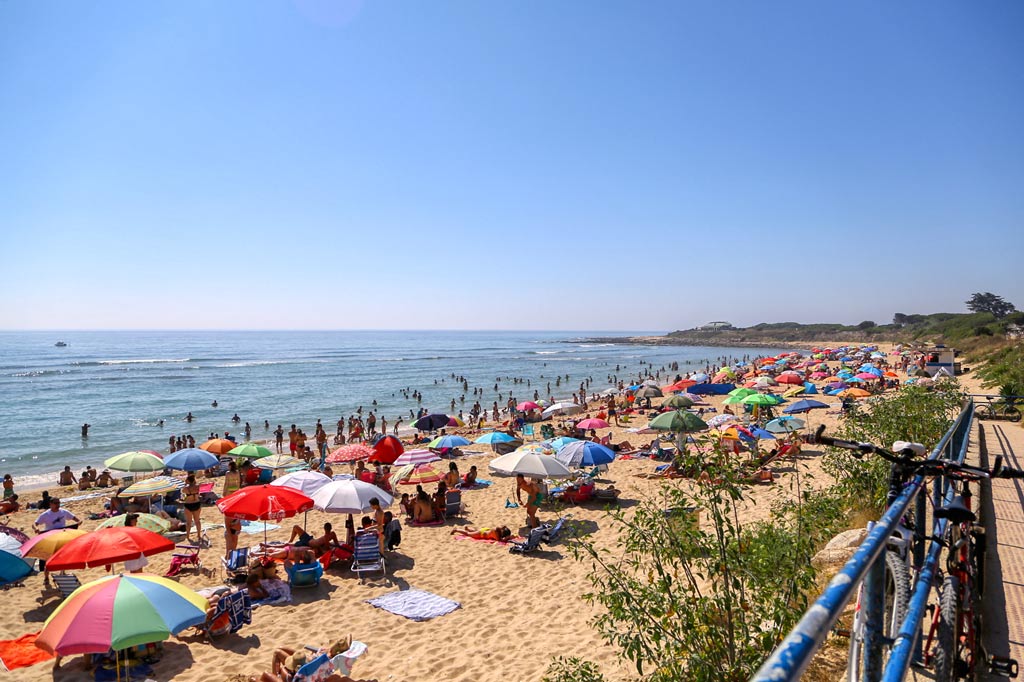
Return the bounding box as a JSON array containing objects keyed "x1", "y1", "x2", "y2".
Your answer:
[{"x1": 751, "y1": 400, "x2": 974, "y2": 682}]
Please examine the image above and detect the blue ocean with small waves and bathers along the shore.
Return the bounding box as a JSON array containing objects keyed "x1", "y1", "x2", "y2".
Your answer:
[{"x1": 0, "y1": 331, "x2": 790, "y2": 487}]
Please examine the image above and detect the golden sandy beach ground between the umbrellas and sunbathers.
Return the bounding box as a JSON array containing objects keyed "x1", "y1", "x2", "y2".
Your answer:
[{"x1": 0, "y1": 339, "x2": 972, "y2": 682}]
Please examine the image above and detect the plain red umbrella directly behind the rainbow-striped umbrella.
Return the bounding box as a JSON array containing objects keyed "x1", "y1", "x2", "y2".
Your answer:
[{"x1": 46, "y1": 525, "x2": 174, "y2": 570}]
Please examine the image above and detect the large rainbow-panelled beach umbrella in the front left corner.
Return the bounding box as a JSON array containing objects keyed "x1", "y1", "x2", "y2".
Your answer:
[{"x1": 36, "y1": 573, "x2": 209, "y2": 656}]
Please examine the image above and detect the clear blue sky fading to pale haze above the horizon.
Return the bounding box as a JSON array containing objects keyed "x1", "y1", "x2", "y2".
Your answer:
[{"x1": 0, "y1": 0, "x2": 1024, "y2": 330}]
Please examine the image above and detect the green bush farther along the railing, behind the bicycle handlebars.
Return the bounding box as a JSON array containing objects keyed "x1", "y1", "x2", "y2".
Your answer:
[{"x1": 822, "y1": 379, "x2": 967, "y2": 513}]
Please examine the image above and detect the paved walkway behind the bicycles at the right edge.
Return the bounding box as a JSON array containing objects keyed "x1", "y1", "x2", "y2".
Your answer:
[{"x1": 971, "y1": 421, "x2": 1024, "y2": 680}]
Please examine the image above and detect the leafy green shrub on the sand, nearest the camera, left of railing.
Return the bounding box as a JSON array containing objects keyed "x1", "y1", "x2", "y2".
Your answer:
[{"x1": 571, "y1": 440, "x2": 825, "y2": 682}]
